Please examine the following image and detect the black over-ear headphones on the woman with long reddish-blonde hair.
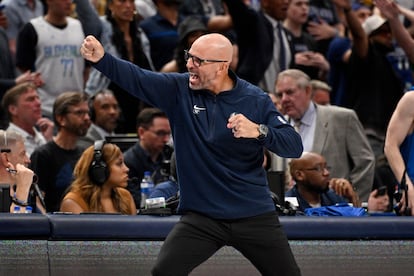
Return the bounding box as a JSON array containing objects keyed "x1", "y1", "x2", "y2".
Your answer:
[{"x1": 89, "y1": 140, "x2": 109, "y2": 186}]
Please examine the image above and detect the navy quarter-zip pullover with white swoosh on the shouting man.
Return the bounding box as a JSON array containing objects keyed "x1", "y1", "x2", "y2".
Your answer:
[{"x1": 94, "y1": 54, "x2": 303, "y2": 219}]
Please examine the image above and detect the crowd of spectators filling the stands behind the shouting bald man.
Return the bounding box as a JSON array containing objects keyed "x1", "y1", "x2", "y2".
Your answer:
[{"x1": 0, "y1": 0, "x2": 414, "y2": 216}]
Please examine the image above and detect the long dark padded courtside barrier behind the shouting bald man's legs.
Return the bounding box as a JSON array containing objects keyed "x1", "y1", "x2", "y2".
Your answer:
[{"x1": 0, "y1": 214, "x2": 414, "y2": 276}]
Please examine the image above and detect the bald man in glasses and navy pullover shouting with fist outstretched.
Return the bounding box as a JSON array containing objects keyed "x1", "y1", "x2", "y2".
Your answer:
[{"x1": 81, "y1": 33, "x2": 303, "y2": 275}]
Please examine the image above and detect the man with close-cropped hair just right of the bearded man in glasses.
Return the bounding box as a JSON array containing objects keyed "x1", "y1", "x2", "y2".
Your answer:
[{"x1": 78, "y1": 89, "x2": 120, "y2": 149}]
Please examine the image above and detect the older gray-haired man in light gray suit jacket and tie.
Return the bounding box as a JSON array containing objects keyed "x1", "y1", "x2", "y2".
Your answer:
[{"x1": 275, "y1": 69, "x2": 375, "y2": 201}]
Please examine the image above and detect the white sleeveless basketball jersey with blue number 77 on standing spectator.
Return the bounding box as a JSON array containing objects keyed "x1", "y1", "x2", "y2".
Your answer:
[{"x1": 30, "y1": 17, "x2": 85, "y2": 115}]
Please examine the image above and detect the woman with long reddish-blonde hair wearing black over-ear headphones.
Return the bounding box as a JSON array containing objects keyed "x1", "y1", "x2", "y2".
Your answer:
[{"x1": 60, "y1": 140, "x2": 137, "y2": 215}]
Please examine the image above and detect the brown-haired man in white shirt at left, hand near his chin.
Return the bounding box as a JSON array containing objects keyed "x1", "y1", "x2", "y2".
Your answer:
[{"x1": 2, "y1": 82, "x2": 54, "y2": 156}]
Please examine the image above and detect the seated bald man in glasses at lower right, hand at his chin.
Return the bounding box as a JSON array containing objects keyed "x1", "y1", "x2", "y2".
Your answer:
[{"x1": 285, "y1": 152, "x2": 389, "y2": 211}]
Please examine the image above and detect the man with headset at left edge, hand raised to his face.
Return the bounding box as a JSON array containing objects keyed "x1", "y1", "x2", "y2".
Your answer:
[{"x1": 0, "y1": 130, "x2": 41, "y2": 213}]
